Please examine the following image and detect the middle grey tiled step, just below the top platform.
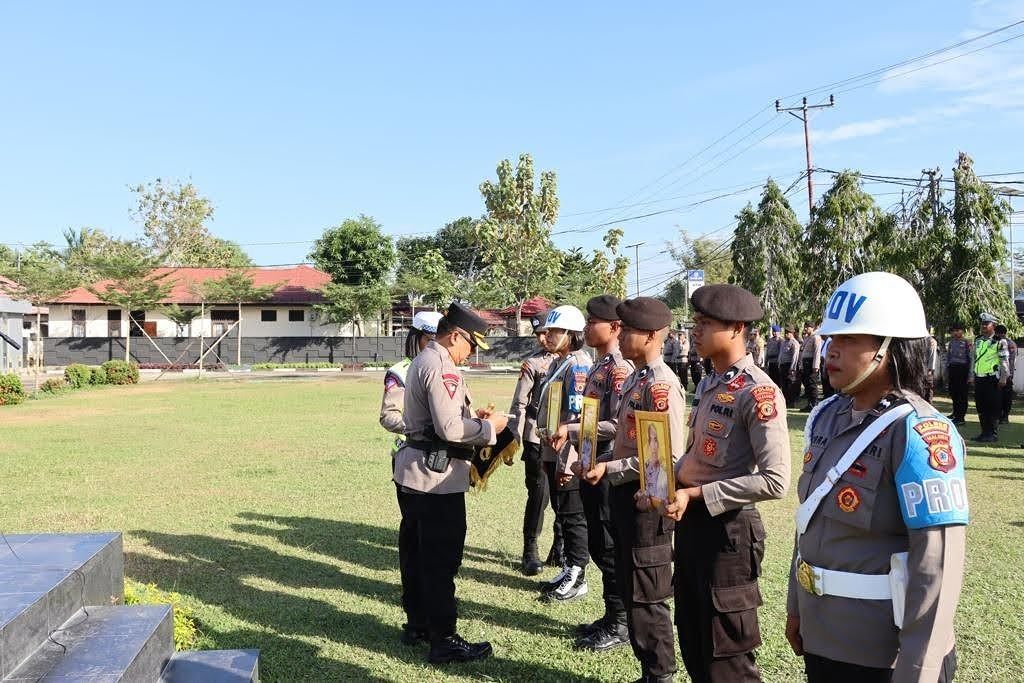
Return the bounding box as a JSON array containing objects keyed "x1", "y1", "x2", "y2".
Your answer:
[{"x1": 3, "y1": 605, "x2": 174, "y2": 683}]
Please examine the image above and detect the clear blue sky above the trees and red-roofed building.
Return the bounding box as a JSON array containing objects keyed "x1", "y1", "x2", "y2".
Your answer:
[{"x1": 0, "y1": 0, "x2": 1024, "y2": 289}]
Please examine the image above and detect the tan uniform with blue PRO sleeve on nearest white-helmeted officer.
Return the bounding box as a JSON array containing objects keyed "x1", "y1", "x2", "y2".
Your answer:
[{"x1": 786, "y1": 391, "x2": 969, "y2": 682}]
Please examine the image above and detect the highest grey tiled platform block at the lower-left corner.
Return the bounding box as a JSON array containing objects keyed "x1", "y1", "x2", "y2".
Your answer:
[{"x1": 0, "y1": 533, "x2": 124, "y2": 679}]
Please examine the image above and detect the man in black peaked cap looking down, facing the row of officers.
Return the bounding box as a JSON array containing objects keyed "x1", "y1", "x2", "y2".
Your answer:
[{"x1": 394, "y1": 303, "x2": 508, "y2": 664}]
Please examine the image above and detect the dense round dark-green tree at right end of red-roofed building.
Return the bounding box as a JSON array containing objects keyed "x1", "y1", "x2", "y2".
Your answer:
[{"x1": 309, "y1": 214, "x2": 396, "y2": 334}]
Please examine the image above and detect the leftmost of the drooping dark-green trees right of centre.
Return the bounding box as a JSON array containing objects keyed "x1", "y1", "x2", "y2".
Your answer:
[{"x1": 731, "y1": 178, "x2": 804, "y2": 323}]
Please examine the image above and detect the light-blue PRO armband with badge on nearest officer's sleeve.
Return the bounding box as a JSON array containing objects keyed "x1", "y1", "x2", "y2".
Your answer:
[{"x1": 895, "y1": 413, "x2": 970, "y2": 528}]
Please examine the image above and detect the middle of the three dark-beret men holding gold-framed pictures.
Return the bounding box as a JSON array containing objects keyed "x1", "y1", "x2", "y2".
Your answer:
[{"x1": 584, "y1": 297, "x2": 686, "y2": 682}]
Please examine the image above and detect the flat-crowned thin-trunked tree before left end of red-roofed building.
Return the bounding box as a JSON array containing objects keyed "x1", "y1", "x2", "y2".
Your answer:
[{"x1": 86, "y1": 250, "x2": 172, "y2": 361}]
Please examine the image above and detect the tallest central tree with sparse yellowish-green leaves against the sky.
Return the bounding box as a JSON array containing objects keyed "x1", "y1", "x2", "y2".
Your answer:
[{"x1": 476, "y1": 154, "x2": 561, "y2": 331}]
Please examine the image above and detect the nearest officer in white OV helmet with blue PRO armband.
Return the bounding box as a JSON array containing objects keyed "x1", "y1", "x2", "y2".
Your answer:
[{"x1": 785, "y1": 272, "x2": 968, "y2": 683}]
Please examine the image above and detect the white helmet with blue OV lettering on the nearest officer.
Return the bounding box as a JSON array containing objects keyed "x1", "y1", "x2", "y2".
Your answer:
[{"x1": 815, "y1": 272, "x2": 929, "y2": 339}]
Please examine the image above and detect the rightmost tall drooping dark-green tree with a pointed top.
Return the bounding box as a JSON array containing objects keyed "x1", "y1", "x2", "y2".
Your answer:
[{"x1": 937, "y1": 153, "x2": 1020, "y2": 332}]
